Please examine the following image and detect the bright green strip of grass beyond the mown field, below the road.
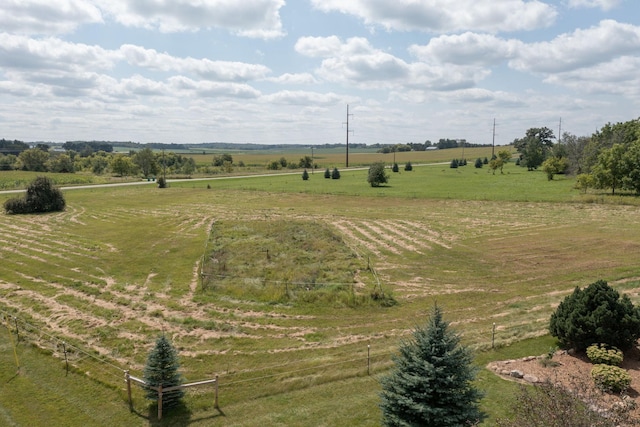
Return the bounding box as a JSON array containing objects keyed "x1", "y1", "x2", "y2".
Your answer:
[{"x1": 171, "y1": 163, "x2": 584, "y2": 202}]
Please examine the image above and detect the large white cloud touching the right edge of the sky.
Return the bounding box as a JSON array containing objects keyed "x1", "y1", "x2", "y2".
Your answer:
[{"x1": 509, "y1": 20, "x2": 640, "y2": 73}]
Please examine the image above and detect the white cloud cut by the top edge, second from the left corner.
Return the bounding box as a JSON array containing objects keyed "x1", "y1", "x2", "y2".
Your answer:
[{"x1": 96, "y1": 0, "x2": 285, "y2": 39}]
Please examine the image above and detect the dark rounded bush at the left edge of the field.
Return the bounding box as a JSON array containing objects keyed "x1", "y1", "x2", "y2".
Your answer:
[{"x1": 4, "y1": 176, "x2": 66, "y2": 214}]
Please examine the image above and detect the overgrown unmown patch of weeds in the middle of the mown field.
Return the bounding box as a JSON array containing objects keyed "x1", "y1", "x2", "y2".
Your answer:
[{"x1": 202, "y1": 219, "x2": 384, "y2": 306}]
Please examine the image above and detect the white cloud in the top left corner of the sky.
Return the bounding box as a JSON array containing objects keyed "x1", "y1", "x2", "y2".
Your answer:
[{"x1": 0, "y1": 0, "x2": 102, "y2": 35}]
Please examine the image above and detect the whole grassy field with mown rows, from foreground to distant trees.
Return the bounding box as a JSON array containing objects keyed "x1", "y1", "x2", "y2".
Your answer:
[{"x1": 0, "y1": 154, "x2": 640, "y2": 426}]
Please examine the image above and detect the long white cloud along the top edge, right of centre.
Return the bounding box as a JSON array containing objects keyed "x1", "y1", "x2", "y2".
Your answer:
[{"x1": 311, "y1": 0, "x2": 557, "y2": 33}]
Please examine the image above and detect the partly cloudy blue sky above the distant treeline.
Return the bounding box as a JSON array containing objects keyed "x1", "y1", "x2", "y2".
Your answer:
[{"x1": 0, "y1": 0, "x2": 640, "y2": 146}]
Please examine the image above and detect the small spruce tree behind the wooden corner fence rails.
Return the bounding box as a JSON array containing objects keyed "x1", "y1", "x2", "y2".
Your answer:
[{"x1": 144, "y1": 335, "x2": 184, "y2": 408}]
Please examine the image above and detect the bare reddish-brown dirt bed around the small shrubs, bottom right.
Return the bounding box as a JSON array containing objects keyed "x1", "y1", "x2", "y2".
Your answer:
[{"x1": 487, "y1": 348, "x2": 640, "y2": 419}]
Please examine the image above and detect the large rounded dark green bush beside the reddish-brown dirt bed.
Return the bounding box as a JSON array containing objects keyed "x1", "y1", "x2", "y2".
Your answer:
[{"x1": 549, "y1": 280, "x2": 640, "y2": 351}]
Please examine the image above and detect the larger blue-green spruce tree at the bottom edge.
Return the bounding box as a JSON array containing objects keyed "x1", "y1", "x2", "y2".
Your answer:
[{"x1": 380, "y1": 306, "x2": 481, "y2": 427}]
